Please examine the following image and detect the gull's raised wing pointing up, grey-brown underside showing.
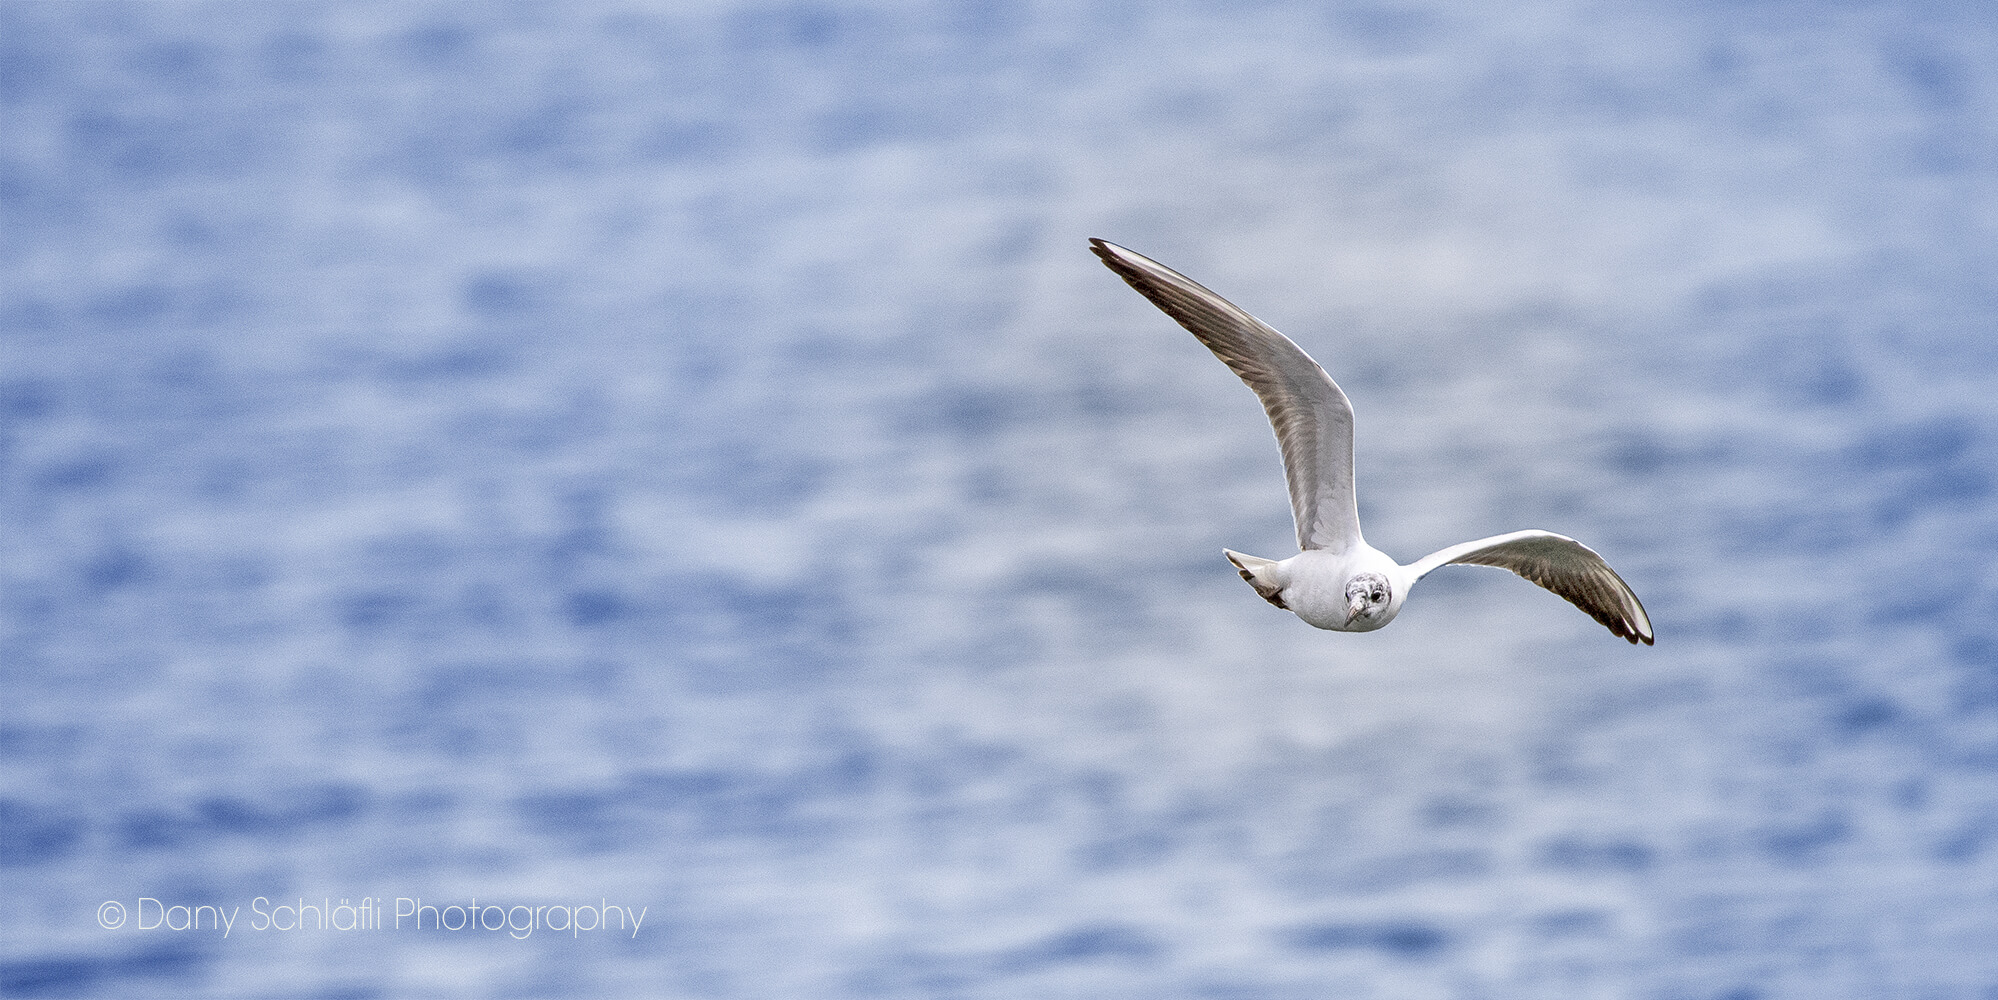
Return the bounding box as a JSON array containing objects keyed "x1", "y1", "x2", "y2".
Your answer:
[{"x1": 1089, "y1": 240, "x2": 1361, "y2": 553}]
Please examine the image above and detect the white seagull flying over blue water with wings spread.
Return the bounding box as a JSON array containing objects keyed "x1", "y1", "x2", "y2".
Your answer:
[{"x1": 1089, "y1": 240, "x2": 1652, "y2": 645}]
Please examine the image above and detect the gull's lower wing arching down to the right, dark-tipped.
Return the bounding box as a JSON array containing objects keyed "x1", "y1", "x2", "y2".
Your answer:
[{"x1": 1409, "y1": 531, "x2": 1652, "y2": 645}]
